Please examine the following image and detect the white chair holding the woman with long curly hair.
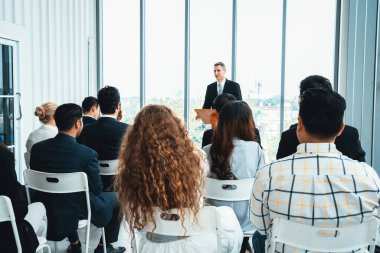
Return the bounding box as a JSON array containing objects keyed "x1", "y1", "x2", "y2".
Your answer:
[{"x1": 132, "y1": 206, "x2": 221, "y2": 253}]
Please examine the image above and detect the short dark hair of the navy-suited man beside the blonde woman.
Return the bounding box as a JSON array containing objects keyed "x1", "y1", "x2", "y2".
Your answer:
[{"x1": 54, "y1": 103, "x2": 83, "y2": 131}]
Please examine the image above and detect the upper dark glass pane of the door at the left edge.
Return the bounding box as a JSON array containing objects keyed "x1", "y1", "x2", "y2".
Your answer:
[{"x1": 0, "y1": 44, "x2": 13, "y2": 96}]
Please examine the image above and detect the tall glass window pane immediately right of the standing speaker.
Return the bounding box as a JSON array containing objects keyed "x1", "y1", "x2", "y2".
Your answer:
[{"x1": 236, "y1": 0, "x2": 282, "y2": 160}]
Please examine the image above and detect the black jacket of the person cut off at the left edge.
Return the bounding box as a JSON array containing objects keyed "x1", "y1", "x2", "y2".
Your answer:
[{"x1": 0, "y1": 143, "x2": 38, "y2": 253}]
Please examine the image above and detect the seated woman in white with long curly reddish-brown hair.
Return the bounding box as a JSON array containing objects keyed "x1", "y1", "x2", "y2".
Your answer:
[{"x1": 115, "y1": 105, "x2": 242, "y2": 253}]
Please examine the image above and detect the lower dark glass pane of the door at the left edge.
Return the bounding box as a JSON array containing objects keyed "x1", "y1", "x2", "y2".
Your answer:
[{"x1": 0, "y1": 97, "x2": 14, "y2": 146}]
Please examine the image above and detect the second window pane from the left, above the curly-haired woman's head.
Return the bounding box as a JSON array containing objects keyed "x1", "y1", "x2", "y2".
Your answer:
[{"x1": 145, "y1": 0, "x2": 185, "y2": 118}]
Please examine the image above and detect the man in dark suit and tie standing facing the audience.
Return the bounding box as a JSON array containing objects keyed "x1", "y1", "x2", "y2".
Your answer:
[{"x1": 202, "y1": 62, "x2": 241, "y2": 109}]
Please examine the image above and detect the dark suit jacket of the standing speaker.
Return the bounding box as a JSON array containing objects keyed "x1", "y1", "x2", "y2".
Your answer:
[{"x1": 202, "y1": 79, "x2": 241, "y2": 109}]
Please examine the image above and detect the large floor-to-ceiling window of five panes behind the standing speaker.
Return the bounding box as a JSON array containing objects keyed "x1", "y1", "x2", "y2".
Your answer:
[{"x1": 102, "y1": 0, "x2": 336, "y2": 160}]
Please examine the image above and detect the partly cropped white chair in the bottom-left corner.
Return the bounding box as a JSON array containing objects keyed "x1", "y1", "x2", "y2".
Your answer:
[{"x1": 0, "y1": 196, "x2": 51, "y2": 253}]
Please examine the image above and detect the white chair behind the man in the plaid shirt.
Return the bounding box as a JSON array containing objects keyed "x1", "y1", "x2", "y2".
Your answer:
[{"x1": 271, "y1": 218, "x2": 379, "y2": 253}]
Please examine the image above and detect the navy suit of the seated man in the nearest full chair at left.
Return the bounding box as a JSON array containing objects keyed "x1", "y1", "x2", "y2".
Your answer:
[{"x1": 30, "y1": 133, "x2": 105, "y2": 241}]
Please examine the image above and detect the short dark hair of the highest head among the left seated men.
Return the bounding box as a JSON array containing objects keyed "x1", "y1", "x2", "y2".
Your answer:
[{"x1": 98, "y1": 86, "x2": 120, "y2": 114}]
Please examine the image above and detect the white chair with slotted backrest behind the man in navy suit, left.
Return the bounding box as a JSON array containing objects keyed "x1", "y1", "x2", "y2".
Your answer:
[{"x1": 24, "y1": 170, "x2": 106, "y2": 253}]
